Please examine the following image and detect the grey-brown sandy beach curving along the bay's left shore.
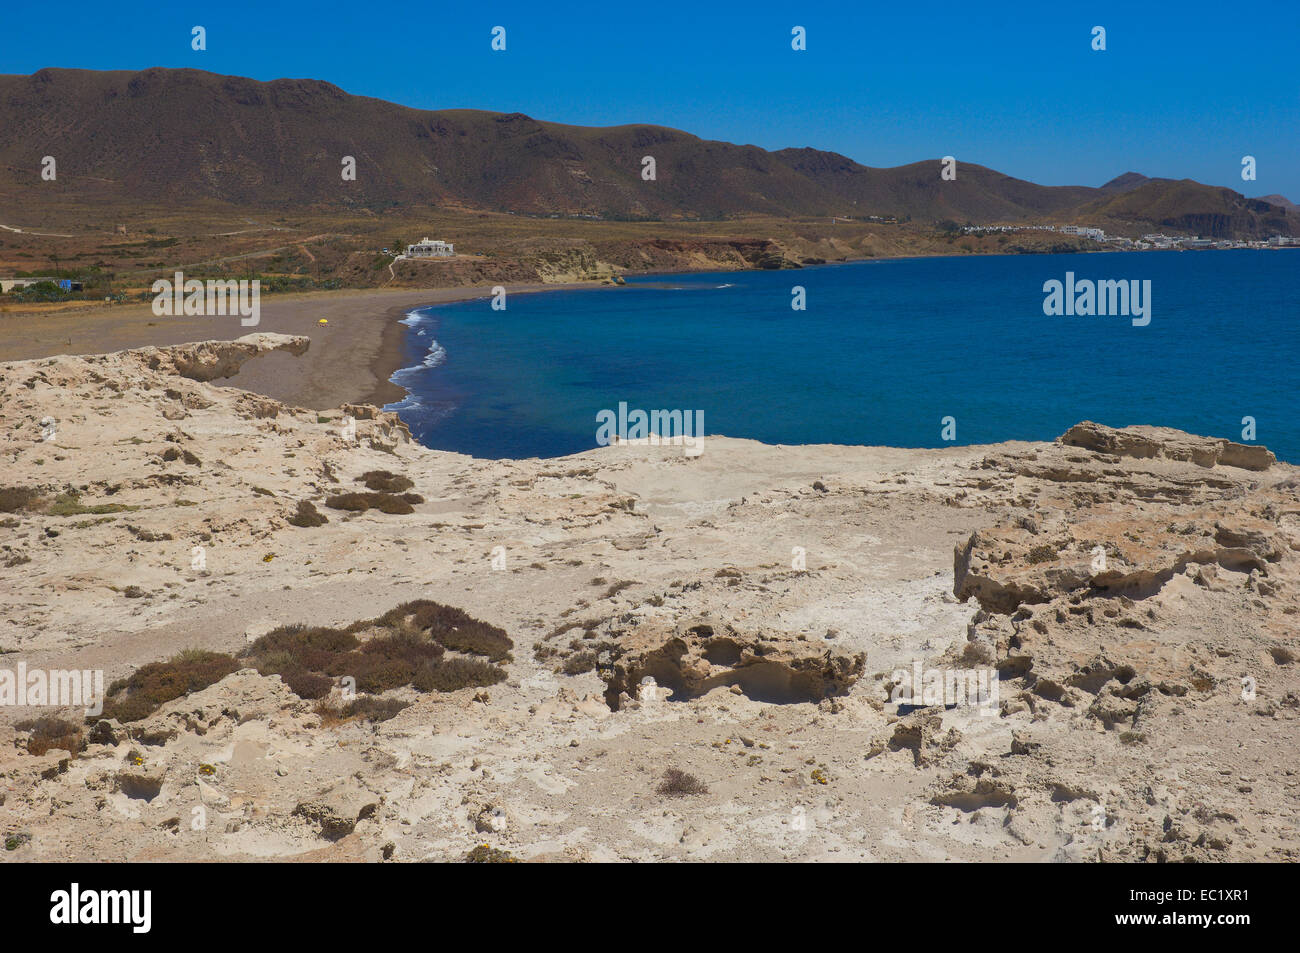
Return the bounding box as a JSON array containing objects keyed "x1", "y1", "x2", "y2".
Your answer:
[{"x1": 0, "y1": 282, "x2": 607, "y2": 410}]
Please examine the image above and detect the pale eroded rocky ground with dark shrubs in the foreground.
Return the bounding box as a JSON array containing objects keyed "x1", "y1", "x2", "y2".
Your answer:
[{"x1": 0, "y1": 334, "x2": 1300, "y2": 861}]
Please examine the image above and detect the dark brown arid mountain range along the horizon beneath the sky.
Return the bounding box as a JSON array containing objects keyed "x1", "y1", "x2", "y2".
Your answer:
[{"x1": 0, "y1": 69, "x2": 1300, "y2": 238}]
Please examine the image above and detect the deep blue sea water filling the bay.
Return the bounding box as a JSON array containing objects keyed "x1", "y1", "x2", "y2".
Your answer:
[{"x1": 391, "y1": 250, "x2": 1300, "y2": 462}]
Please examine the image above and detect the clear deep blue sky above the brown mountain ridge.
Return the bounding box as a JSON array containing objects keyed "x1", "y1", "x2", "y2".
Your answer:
[{"x1": 10, "y1": 0, "x2": 1300, "y2": 202}]
